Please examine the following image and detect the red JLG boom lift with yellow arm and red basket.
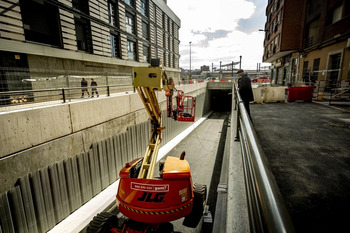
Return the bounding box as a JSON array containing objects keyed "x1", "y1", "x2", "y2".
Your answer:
[{"x1": 87, "y1": 61, "x2": 207, "y2": 233}]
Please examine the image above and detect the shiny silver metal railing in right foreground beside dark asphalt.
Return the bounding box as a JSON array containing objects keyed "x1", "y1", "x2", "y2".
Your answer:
[{"x1": 233, "y1": 84, "x2": 295, "y2": 233}]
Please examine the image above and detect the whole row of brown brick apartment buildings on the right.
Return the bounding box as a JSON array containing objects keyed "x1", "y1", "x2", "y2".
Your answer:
[{"x1": 263, "y1": 0, "x2": 350, "y2": 90}]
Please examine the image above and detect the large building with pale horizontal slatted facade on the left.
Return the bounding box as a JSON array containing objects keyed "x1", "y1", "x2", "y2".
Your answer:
[{"x1": 0, "y1": 0, "x2": 181, "y2": 91}]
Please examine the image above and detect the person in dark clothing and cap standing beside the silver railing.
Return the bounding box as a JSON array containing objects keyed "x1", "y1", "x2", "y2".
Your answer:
[{"x1": 236, "y1": 69, "x2": 254, "y2": 120}]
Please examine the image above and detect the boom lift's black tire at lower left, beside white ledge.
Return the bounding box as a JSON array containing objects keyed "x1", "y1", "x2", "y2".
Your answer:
[{"x1": 86, "y1": 212, "x2": 118, "y2": 233}]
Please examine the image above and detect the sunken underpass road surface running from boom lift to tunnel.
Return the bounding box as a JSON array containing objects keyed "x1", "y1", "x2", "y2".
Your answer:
[{"x1": 167, "y1": 112, "x2": 229, "y2": 233}]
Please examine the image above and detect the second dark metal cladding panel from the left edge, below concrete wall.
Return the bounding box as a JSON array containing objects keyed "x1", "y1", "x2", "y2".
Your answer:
[{"x1": 9, "y1": 186, "x2": 29, "y2": 233}]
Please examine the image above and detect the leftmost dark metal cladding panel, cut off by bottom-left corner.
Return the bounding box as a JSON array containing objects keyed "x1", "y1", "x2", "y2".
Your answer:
[{"x1": 0, "y1": 192, "x2": 15, "y2": 233}]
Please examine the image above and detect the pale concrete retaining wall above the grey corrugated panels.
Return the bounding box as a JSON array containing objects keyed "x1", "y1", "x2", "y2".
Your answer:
[{"x1": 0, "y1": 83, "x2": 206, "y2": 193}]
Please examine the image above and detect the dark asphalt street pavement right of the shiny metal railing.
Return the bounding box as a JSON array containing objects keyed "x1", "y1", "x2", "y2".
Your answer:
[{"x1": 251, "y1": 102, "x2": 350, "y2": 233}]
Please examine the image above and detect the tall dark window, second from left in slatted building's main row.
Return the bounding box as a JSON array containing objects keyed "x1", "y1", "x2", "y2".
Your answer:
[{"x1": 74, "y1": 18, "x2": 92, "y2": 53}]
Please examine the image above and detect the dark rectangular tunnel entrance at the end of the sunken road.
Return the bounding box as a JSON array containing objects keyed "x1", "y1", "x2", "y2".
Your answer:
[{"x1": 209, "y1": 90, "x2": 232, "y2": 112}]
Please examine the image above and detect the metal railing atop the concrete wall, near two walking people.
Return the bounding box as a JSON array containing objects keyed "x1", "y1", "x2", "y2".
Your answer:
[{"x1": 0, "y1": 84, "x2": 134, "y2": 107}]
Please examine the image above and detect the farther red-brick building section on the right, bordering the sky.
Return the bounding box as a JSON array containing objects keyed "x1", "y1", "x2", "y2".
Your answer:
[{"x1": 263, "y1": 0, "x2": 304, "y2": 85}]
